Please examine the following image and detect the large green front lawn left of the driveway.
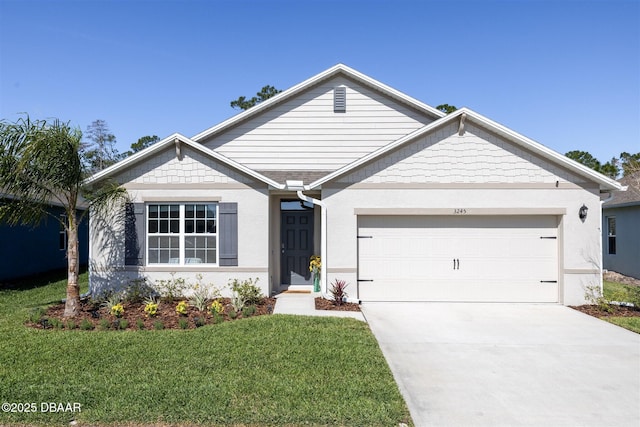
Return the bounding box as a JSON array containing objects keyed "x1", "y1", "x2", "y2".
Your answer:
[{"x1": 0, "y1": 274, "x2": 410, "y2": 426}]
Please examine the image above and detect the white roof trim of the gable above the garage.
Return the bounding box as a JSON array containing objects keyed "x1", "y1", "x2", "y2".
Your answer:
[{"x1": 308, "y1": 107, "x2": 622, "y2": 190}]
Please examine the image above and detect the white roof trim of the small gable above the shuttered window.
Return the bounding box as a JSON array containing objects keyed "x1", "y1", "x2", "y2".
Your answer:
[{"x1": 85, "y1": 133, "x2": 282, "y2": 188}]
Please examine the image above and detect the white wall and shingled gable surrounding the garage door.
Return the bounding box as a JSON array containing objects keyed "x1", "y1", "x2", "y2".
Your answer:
[{"x1": 322, "y1": 126, "x2": 601, "y2": 305}]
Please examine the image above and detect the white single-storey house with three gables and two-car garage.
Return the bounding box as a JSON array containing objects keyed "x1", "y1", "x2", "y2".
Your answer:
[{"x1": 89, "y1": 65, "x2": 621, "y2": 304}]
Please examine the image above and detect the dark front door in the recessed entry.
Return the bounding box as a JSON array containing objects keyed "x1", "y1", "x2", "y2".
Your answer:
[{"x1": 280, "y1": 203, "x2": 313, "y2": 285}]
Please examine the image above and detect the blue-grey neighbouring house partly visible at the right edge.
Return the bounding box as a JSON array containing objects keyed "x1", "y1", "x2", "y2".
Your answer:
[{"x1": 602, "y1": 172, "x2": 640, "y2": 279}]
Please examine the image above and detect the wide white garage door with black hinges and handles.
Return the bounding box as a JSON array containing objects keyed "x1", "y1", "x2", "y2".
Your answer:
[{"x1": 358, "y1": 216, "x2": 558, "y2": 302}]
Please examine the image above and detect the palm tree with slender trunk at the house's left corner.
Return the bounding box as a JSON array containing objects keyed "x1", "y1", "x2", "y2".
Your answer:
[{"x1": 0, "y1": 116, "x2": 126, "y2": 317}]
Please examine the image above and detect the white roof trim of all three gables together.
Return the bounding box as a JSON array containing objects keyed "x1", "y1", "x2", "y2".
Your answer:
[{"x1": 85, "y1": 64, "x2": 622, "y2": 191}]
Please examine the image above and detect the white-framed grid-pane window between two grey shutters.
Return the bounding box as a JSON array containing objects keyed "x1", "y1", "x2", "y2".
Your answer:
[{"x1": 147, "y1": 203, "x2": 218, "y2": 265}]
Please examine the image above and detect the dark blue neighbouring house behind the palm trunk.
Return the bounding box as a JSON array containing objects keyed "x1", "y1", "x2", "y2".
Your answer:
[{"x1": 0, "y1": 198, "x2": 89, "y2": 283}]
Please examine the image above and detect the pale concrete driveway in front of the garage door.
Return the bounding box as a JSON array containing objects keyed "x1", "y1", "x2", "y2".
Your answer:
[{"x1": 362, "y1": 303, "x2": 640, "y2": 427}]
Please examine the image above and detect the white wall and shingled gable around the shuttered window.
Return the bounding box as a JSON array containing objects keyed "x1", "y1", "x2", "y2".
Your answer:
[{"x1": 91, "y1": 148, "x2": 269, "y2": 295}]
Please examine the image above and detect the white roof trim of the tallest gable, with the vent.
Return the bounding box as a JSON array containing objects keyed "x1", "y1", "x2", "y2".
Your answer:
[{"x1": 191, "y1": 64, "x2": 445, "y2": 142}]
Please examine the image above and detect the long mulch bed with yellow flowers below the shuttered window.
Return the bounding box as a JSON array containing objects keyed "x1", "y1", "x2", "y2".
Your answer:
[{"x1": 29, "y1": 298, "x2": 276, "y2": 330}]
